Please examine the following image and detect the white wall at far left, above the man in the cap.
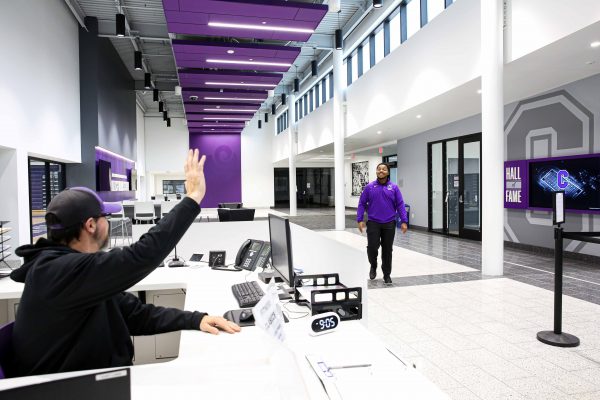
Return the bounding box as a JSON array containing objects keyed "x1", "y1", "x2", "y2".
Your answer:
[{"x1": 0, "y1": 0, "x2": 81, "y2": 252}]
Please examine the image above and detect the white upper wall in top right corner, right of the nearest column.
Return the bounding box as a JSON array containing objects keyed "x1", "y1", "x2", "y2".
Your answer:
[{"x1": 505, "y1": 0, "x2": 600, "y2": 62}]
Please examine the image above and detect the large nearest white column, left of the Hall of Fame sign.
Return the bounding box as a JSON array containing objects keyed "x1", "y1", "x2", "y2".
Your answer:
[{"x1": 481, "y1": 0, "x2": 504, "y2": 275}]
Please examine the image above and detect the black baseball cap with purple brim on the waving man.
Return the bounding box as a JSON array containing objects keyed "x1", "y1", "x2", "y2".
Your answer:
[{"x1": 46, "y1": 186, "x2": 121, "y2": 229}]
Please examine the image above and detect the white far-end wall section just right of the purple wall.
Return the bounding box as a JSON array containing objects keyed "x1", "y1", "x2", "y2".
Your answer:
[{"x1": 241, "y1": 113, "x2": 277, "y2": 208}]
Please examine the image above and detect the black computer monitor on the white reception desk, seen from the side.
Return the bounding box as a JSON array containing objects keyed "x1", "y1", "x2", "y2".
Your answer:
[{"x1": 269, "y1": 214, "x2": 294, "y2": 287}]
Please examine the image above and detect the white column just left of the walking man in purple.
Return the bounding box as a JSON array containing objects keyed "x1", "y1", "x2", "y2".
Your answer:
[{"x1": 333, "y1": 50, "x2": 346, "y2": 231}]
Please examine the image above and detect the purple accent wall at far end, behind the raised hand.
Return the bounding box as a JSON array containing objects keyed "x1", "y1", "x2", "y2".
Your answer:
[{"x1": 190, "y1": 133, "x2": 242, "y2": 207}]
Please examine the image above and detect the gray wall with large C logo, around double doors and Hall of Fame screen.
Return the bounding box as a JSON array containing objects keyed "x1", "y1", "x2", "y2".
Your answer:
[{"x1": 398, "y1": 75, "x2": 600, "y2": 255}]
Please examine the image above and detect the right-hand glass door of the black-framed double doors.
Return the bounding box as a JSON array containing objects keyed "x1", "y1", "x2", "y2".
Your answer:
[{"x1": 458, "y1": 135, "x2": 481, "y2": 240}]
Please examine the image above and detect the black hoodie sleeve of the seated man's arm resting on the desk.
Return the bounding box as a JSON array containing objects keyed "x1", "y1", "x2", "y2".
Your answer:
[{"x1": 118, "y1": 293, "x2": 206, "y2": 336}]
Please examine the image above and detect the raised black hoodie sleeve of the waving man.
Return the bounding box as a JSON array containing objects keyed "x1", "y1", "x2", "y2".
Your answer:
[{"x1": 34, "y1": 197, "x2": 200, "y2": 309}]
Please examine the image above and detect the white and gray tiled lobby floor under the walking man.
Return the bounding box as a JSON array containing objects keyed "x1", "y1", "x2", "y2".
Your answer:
[{"x1": 284, "y1": 208, "x2": 600, "y2": 400}]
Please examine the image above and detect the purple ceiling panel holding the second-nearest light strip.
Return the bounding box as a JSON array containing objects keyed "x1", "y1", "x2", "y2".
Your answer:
[{"x1": 173, "y1": 40, "x2": 300, "y2": 72}]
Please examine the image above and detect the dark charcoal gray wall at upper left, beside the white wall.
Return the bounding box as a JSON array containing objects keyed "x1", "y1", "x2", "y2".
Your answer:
[{"x1": 66, "y1": 17, "x2": 137, "y2": 189}]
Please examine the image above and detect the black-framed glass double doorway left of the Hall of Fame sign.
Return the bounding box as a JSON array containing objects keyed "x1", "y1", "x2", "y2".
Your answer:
[{"x1": 427, "y1": 133, "x2": 481, "y2": 240}]
